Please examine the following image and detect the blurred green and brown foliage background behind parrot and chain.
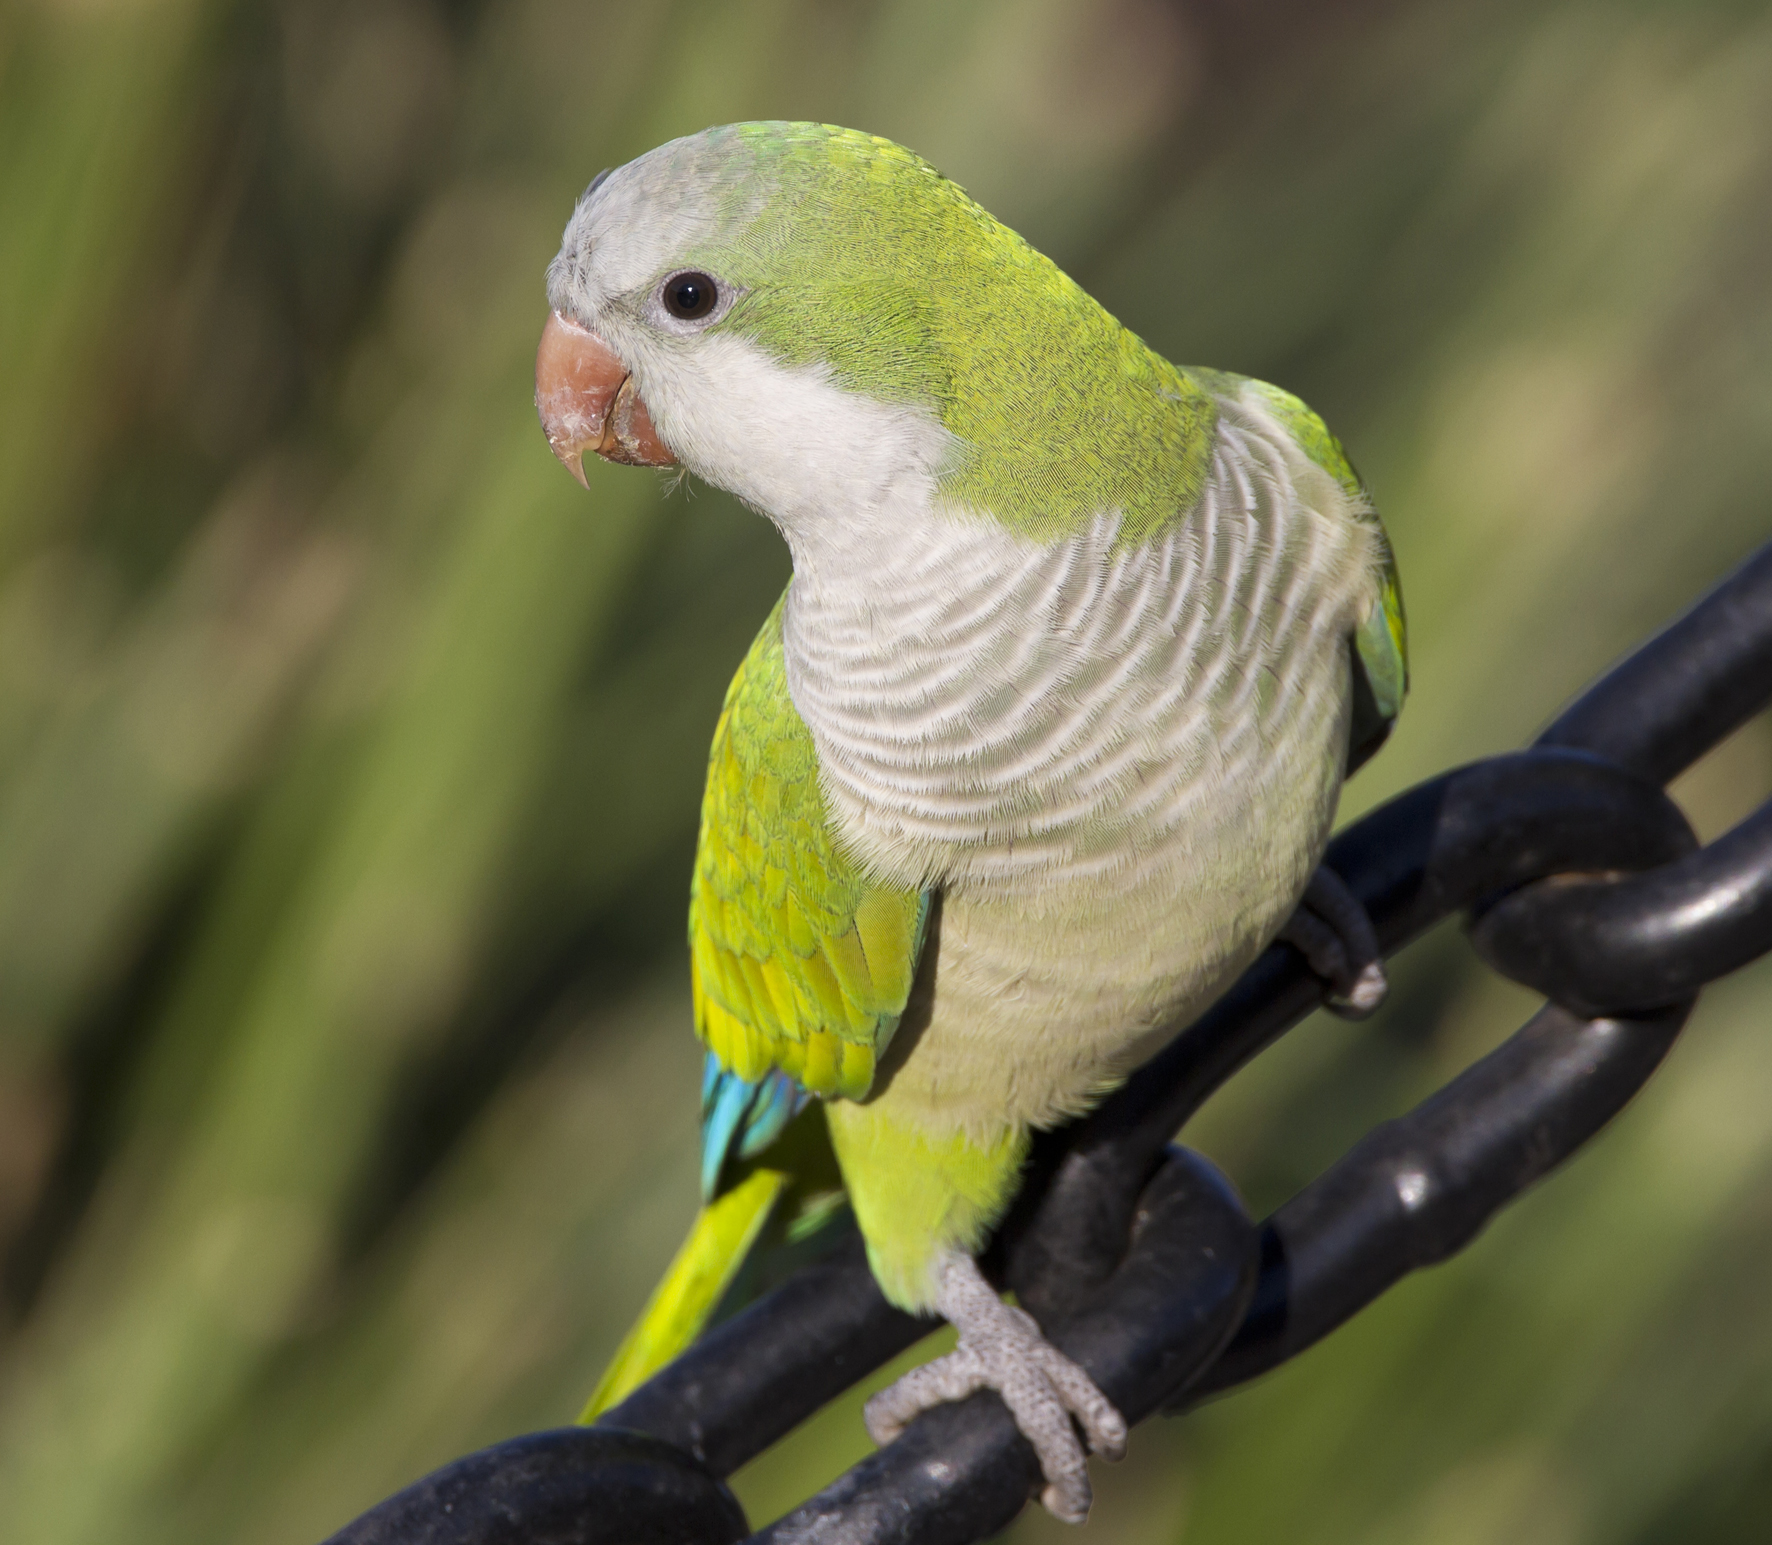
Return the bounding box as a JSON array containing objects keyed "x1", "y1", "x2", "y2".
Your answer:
[{"x1": 0, "y1": 0, "x2": 1772, "y2": 1545}]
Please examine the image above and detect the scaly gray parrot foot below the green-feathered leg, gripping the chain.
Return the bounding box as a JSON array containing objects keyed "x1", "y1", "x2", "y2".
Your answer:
[{"x1": 861, "y1": 1253, "x2": 1125, "y2": 1524}]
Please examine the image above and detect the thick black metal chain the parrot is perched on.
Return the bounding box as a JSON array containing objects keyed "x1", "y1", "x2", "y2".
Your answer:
[{"x1": 318, "y1": 546, "x2": 1772, "y2": 1545}]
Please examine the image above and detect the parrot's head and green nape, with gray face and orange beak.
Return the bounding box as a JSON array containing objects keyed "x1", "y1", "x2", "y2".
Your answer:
[{"x1": 535, "y1": 122, "x2": 1204, "y2": 542}]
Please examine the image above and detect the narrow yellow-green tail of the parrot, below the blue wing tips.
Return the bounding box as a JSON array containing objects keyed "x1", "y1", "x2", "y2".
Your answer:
[{"x1": 578, "y1": 1169, "x2": 789, "y2": 1423}]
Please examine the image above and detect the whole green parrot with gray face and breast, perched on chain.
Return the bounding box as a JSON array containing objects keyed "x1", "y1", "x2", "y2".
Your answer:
[{"x1": 537, "y1": 122, "x2": 1405, "y2": 1520}]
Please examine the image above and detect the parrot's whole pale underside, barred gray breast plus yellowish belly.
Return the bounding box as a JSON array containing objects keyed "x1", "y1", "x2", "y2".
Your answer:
[{"x1": 783, "y1": 386, "x2": 1377, "y2": 1127}]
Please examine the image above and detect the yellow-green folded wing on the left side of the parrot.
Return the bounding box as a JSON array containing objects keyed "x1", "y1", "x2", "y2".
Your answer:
[{"x1": 689, "y1": 602, "x2": 929, "y2": 1099}]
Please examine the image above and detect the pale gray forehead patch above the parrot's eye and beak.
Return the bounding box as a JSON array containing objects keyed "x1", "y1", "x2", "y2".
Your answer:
[{"x1": 548, "y1": 129, "x2": 769, "y2": 310}]
